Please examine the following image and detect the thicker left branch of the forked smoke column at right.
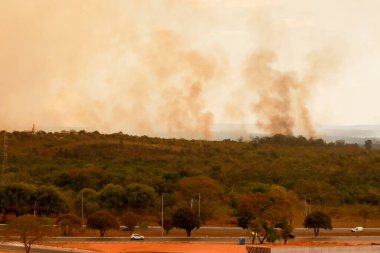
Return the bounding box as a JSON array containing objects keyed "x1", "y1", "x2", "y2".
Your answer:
[{"x1": 245, "y1": 50, "x2": 304, "y2": 135}]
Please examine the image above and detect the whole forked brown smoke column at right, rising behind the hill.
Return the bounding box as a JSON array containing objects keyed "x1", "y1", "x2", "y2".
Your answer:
[{"x1": 244, "y1": 50, "x2": 337, "y2": 136}]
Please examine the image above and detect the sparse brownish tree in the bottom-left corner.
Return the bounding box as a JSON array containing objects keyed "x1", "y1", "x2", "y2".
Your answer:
[{"x1": 5, "y1": 215, "x2": 52, "y2": 253}]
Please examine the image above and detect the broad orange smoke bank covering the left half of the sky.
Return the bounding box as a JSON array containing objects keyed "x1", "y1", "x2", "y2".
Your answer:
[{"x1": 0, "y1": 0, "x2": 220, "y2": 139}]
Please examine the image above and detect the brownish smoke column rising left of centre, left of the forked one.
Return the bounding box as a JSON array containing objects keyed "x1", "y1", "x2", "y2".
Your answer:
[{"x1": 137, "y1": 30, "x2": 218, "y2": 139}]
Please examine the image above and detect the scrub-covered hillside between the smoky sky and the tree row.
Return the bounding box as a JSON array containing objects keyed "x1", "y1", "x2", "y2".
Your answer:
[{"x1": 1, "y1": 131, "x2": 380, "y2": 206}]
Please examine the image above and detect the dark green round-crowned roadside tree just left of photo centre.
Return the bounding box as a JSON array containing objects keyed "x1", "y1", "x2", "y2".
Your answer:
[{"x1": 173, "y1": 208, "x2": 201, "y2": 237}]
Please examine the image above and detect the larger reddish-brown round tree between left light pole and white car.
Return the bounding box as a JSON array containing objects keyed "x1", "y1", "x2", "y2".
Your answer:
[{"x1": 87, "y1": 210, "x2": 119, "y2": 237}]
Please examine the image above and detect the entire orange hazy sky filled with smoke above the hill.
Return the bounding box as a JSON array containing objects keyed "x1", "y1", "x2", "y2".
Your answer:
[{"x1": 0, "y1": 0, "x2": 380, "y2": 139}]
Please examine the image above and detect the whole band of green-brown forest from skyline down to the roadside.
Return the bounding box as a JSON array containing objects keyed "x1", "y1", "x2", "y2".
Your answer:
[{"x1": 0, "y1": 131, "x2": 380, "y2": 226}]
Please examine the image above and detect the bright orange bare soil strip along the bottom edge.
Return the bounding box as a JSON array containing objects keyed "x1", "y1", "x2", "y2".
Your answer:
[{"x1": 44, "y1": 242, "x2": 369, "y2": 253}]
